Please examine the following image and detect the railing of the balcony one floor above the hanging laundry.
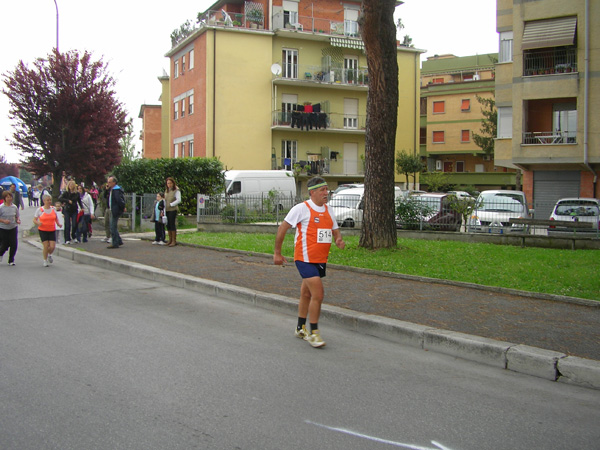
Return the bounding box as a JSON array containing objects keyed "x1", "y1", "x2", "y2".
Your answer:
[{"x1": 276, "y1": 62, "x2": 369, "y2": 86}]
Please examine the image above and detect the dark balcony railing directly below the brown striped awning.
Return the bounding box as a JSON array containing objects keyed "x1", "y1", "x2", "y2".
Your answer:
[{"x1": 523, "y1": 47, "x2": 577, "y2": 76}]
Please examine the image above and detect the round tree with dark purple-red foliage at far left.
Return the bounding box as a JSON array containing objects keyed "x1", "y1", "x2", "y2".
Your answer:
[{"x1": 2, "y1": 51, "x2": 128, "y2": 197}]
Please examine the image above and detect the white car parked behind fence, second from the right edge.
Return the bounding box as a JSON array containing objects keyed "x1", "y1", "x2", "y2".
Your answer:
[{"x1": 468, "y1": 190, "x2": 531, "y2": 234}]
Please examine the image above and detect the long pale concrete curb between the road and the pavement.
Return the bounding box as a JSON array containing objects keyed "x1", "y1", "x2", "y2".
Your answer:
[{"x1": 27, "y1": 240, "x2": 600, "y2": 390}]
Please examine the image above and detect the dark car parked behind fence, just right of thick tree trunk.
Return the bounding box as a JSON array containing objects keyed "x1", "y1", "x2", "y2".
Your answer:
[{"x1": 396, "y1": 193, "x2": 462, "y2": 231}]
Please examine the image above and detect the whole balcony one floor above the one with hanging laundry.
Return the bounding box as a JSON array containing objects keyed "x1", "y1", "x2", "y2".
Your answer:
[{"x1": 273, "y1": 62, "x2": 369, "y2": 90}]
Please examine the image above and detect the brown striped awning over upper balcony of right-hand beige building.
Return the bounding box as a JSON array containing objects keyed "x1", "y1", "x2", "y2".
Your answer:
[{"x1": 521, "y1": 17, "x2": 577, "y2": 50}]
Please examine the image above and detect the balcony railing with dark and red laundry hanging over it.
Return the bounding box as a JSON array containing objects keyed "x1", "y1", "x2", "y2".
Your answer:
[{"x1": 272, "y1": 110, "x2": 367, "y2": 131}]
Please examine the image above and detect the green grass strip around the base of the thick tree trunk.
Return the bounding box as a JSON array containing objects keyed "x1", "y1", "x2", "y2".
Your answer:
[{"x1": 177, "y1": 233, "x2": 600, "y2": 300}]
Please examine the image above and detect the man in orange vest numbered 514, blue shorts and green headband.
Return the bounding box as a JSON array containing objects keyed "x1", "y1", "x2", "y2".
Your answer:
[{"x1": 273, "y1": 177, "x2": 346, "y2": 348}]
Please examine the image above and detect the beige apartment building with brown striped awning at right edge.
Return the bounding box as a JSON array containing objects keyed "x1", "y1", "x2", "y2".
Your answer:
[{"x1": 495, "y1": 0, "x2": 600, "y2": 219}]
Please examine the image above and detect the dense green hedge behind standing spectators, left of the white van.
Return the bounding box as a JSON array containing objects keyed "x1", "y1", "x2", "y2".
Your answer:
[{"x1": 112, "y1": 158, "x2": 225, "y2": 214}]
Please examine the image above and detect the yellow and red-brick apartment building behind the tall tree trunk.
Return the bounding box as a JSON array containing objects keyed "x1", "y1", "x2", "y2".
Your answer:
[{"x1": 166, "y1": 0, "x2": 420, "y2": 191}]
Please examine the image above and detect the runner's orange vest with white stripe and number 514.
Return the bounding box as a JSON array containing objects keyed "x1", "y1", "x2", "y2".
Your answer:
[{"x1": 294, "y1": 202, "x2": 337, "y2": 263}]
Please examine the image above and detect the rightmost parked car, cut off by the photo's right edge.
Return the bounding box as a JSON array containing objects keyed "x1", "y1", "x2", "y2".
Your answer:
[{"x1": 548, "y1": 198, "x2": 600, "y2": 235}]
